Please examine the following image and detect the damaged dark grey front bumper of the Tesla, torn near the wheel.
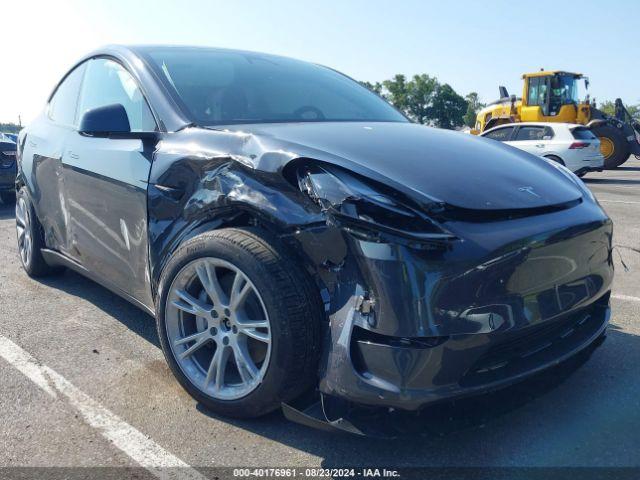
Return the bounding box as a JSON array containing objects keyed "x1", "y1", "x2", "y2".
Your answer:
[{"x1": 284, "y1": 197, "x2": 613, "y2": 433}]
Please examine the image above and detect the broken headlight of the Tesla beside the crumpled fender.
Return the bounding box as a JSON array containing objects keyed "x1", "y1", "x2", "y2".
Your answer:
[{"x1": 298, "y1": 166, "x2": 455, "y2": 243}]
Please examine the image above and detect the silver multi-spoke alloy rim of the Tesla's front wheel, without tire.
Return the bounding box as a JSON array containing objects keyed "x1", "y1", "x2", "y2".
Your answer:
[{"x1": 165, "y1": 257, "x2": 271, "y2": 400}]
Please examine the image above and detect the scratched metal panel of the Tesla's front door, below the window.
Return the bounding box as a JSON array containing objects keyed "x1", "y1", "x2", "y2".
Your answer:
[{"x1": 63, "y1": 134, "x2": 153, "y2": 308}]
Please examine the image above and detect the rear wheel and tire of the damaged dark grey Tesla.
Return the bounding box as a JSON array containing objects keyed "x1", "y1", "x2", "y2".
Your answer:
[{"x1": 16, "y1": 187, "x2": 62, "y2": 278}]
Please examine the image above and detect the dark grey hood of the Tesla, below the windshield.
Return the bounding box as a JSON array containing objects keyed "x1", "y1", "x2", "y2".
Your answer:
[{"x1": 218, "y1": 122, "x2": 582, "y2": 210}]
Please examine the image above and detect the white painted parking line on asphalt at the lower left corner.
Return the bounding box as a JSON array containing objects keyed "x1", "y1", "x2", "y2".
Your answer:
[{"x1": 0, "y1": 335, "x2": 206, "y2": 480}]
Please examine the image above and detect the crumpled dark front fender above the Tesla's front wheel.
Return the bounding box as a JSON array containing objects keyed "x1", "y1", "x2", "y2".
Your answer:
[{"x1": 148, "y1": 131, "x2": 323, "y2": 292}]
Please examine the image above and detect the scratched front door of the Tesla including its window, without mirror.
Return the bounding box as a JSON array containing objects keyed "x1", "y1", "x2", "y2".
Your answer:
[{"x1": 63, "y1": 58, "x2": 156, "y2": 307}]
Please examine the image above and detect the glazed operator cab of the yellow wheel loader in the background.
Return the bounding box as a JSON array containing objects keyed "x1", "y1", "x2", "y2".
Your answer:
[{"x1": 520, "y1": 71, "x2": 587, "y2": 123}]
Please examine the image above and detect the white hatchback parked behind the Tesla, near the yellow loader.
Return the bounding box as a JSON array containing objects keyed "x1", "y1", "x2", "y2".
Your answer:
[{"x1": 481, "y1": 122, "x2": 604, "y2": 177}]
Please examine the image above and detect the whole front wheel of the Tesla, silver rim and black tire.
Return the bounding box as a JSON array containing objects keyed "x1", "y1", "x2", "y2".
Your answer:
[{"x1": 156, "y1": 229, "x2": 323, "y2": 417}]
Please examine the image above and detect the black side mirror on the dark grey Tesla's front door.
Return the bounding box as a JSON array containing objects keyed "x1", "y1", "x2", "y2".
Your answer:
[{"x1": 80, "y1": 103, "x2": 157, "y2": 139}]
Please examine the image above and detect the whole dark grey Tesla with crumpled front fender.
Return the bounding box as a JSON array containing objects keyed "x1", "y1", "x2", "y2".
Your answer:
[{"x1": 16, "y1": 46, "x2": 613, "y2": 430}]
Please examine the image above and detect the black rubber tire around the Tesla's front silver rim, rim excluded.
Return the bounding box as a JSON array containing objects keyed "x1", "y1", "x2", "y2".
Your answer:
[{"x1": 156, "y1": 228, "x2": 324, "y2": 418}]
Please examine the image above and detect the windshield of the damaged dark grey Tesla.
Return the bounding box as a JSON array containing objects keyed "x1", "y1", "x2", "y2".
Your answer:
[{"x1": 145, "y1": 48, "x2": 408, "y2": 125}]
